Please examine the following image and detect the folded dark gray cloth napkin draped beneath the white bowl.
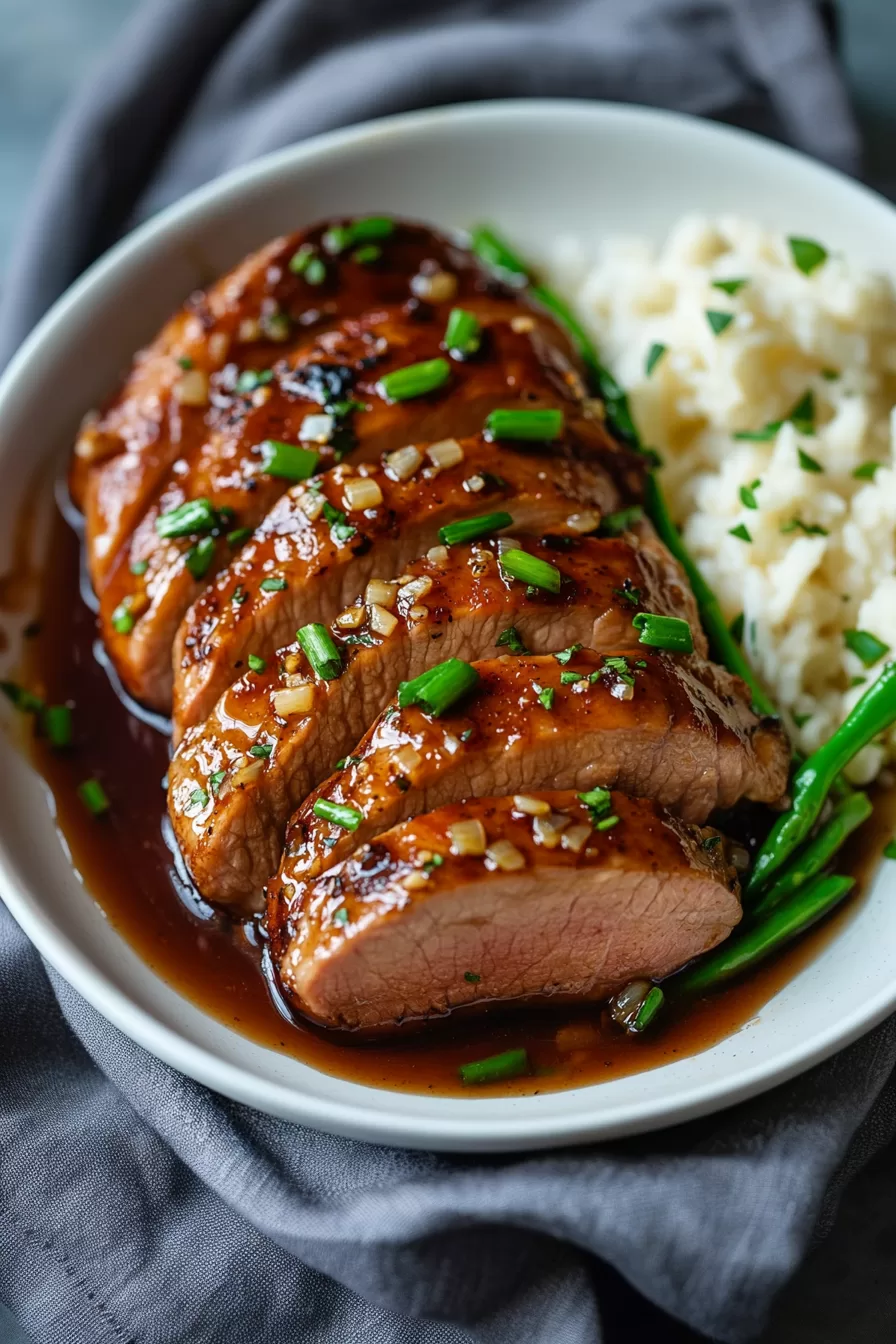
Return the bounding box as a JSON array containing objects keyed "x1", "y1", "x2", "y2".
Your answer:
[{"x1": 0, "y1": 0, "x2": 896, "y2": 1344}]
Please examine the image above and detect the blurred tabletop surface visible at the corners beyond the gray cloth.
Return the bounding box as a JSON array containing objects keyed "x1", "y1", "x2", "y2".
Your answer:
[{"x1": 0, "y1": 0, "x2": 896, "y2": 1344}]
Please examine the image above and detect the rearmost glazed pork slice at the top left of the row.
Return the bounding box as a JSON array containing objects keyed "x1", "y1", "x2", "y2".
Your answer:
[{"x1": 70, "y1": 220, "x2": 518, "y2": 591}]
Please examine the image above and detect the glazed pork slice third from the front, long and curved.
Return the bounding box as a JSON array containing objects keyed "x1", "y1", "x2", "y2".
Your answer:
[{"x1": 168, "y1": 538, "x2": 705, "y2": 909}]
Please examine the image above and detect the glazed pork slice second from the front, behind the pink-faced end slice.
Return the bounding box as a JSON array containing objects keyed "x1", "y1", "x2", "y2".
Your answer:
[{"x1": 274, "y1": 645, "x2": 789, "y2": 899}]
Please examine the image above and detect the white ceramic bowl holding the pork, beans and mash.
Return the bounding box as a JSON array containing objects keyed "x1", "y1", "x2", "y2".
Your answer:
[{"x1": 0, "y1": 101, "x2": 896, "y2": 1149}]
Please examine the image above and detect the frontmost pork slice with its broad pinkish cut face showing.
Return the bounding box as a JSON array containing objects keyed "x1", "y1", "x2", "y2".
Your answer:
[{"x1": 269, "y1": 792, "x2": 740, "y2": 1031}]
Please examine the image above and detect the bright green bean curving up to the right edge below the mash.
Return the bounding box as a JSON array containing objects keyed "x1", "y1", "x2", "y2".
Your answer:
[{"x1": 747, "y1": 663, "x2": 896, "y2": 895}]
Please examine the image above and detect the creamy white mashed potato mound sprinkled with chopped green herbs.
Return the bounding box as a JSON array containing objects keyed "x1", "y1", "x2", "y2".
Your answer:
[{"x1": 551, "y1": 218, "x2": 896, "y2": 782}]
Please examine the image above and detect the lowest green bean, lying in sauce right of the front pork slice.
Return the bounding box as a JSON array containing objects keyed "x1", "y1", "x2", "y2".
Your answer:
[{"x1": 665, "y1": 876, "x2": 856, "y2": 999}]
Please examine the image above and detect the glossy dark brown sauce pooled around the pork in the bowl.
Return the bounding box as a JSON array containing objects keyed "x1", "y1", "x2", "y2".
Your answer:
[{"x1": 12, "y1": 499, "x2": 892, "y2": 1095}]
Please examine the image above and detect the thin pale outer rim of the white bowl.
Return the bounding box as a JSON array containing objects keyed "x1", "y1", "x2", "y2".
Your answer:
[{"x1": 0, "y1": 98, "x2": 896, "y2": 1150}]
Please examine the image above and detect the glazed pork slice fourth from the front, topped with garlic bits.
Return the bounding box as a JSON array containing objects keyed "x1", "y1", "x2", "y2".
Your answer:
[{"x1": 169, "y1": 430, "x2": 631, "y2": 731}]
